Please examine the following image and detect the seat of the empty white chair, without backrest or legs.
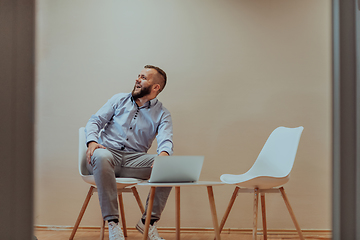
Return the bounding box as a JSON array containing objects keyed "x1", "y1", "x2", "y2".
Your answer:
[{"x1": 220, "y1": 173, "x2": 290, "y2": 189}]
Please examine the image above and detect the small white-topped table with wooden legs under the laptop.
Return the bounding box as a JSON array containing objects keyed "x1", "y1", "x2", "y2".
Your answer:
[{"x1": 138, "y1": 181, "x2": 224, "y2": 240}]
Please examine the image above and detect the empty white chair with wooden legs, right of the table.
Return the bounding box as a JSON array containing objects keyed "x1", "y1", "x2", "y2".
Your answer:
[{"x1": 220, "y1": 127, "x2": 304, "y2": 240}]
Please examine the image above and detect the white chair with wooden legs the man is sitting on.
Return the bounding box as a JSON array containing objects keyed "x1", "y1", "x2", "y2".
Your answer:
[{"x1": 69, "y1": 127, "x2": 145, "y2": 240}]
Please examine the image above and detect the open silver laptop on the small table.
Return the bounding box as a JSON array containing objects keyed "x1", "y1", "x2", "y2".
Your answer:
[{"x1": 149, "y1": 156, "x2": 204, "y2": 183}]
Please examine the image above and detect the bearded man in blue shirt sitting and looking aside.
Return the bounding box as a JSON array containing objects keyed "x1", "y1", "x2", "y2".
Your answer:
[{"x1": 85, "y1": 65, "x2": 173, "y2": 240}]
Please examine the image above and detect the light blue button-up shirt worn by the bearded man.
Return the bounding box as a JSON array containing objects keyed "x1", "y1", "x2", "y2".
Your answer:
[{"x1": 85, "y1": 93, "x2": 173, "y2": 155}]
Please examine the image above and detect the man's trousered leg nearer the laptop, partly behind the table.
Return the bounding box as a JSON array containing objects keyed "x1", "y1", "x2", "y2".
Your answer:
[{"x1": 120, "y1": 153, "x2": 171, "y2": 224}]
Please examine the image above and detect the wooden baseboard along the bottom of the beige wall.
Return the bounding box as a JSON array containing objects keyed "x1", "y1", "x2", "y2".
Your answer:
[{"x1": 35, "y1": 225, "x2": 332, "y2": 238}]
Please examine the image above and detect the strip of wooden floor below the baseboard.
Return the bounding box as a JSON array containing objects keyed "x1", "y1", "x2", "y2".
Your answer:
[{"x1": 34, "y1": 229, "x2": 331, "y2": 240}]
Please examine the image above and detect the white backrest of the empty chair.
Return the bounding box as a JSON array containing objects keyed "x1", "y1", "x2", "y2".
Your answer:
[{"x1": 248, "y1": 127, "x2": 304, "y2": 178}]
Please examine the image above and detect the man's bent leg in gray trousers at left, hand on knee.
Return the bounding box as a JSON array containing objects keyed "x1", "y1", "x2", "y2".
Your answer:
[{"x1": 87, "y1": 148, "x2": 121, "y2": 221}]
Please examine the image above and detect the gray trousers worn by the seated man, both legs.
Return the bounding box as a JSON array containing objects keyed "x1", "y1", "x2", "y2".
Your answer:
[{"x1": 87, "y1": 148, "x2": 171, "y2": 221}]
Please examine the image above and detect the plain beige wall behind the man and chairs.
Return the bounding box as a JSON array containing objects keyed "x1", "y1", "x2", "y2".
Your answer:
[{"x1": 35, "y1": 0, "x2": 331, "y2": 229}]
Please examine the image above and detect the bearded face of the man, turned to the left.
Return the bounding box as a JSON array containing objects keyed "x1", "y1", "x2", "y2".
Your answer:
[{"x1": 131, "y1": 68, "x2": 156, "y2": 100}]
